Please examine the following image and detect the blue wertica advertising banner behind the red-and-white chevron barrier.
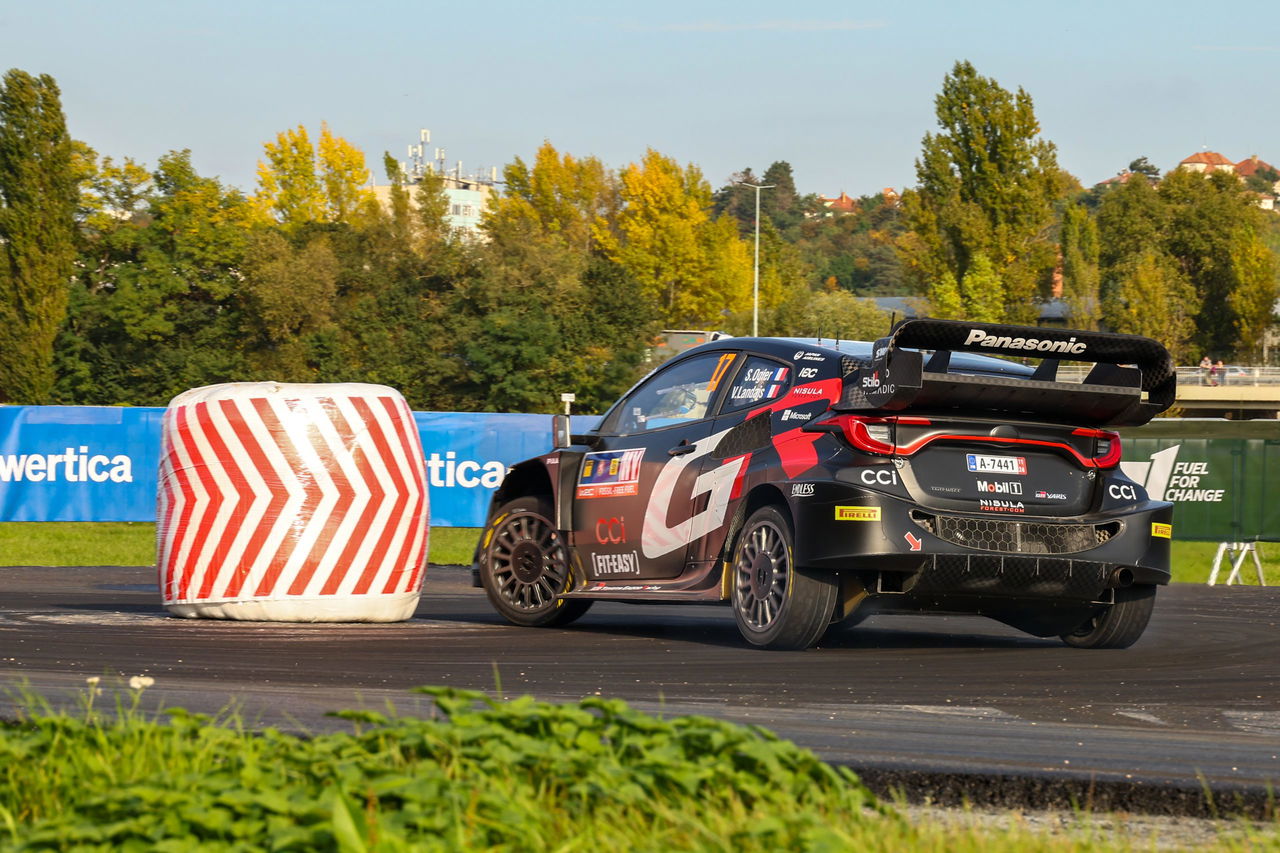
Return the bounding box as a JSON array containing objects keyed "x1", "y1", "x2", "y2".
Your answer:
[{"x1": 0, "y1": 406, "x2": 599, "y2": 528}]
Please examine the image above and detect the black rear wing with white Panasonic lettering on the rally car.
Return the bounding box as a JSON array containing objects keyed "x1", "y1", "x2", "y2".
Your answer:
[{"x1": 835, "y1": 320, "x2": 1178, "y2": 427}]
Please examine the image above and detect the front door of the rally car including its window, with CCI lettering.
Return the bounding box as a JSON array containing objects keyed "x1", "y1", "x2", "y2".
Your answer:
[{"x1": 572, "y1": 352, "x2": 737, "y2": 581}]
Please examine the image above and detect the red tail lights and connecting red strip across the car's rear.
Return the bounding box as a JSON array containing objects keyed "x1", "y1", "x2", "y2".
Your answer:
[{"x1": 806, "y1": 414, "x2": 1120, "y2": 469}]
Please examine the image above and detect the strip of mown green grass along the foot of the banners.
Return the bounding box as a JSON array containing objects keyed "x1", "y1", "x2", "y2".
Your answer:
[{"x1": 0, "y1": 521, "x2": 1280, "y2": 587}]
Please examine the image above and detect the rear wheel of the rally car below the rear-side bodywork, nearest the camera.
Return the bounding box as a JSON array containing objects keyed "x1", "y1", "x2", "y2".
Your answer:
[{"x1": 728, "y1": 506, "x2": 837, "y2": 651}]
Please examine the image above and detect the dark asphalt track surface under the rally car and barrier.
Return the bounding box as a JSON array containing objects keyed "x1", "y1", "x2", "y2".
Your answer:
[{"x1": 0, "y1": 566, "x2": 1280, "y2": 813}]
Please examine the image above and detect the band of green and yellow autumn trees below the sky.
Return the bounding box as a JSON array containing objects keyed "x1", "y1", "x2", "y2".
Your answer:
[{"x1": 0, "y1": 61, "x2": 1280, "y2": 411}]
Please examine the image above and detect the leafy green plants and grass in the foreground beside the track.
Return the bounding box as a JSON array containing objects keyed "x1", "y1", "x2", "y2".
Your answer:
[{"x1": 0, "y1": 686, "x2": 908, "y2": 850}]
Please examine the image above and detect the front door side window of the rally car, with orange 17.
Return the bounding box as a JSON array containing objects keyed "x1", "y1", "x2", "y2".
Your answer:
[{"x1": 613, "y1": 352, "x2": 735, "y2": 434}]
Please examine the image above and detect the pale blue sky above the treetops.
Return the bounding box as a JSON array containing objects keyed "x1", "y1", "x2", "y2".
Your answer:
[{"x1": 0, "y1": 0, "x2": 1280, "y2": 196}]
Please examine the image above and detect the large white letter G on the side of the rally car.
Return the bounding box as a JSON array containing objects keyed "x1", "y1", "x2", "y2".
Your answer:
[{"x1": 640, "y1": 429, "x2": 748, "y2": 560}]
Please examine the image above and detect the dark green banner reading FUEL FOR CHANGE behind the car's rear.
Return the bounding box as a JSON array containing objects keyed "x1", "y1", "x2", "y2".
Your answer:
[{"x1": 1120, "y1": 418, "x2": 1280, "y2": 542}]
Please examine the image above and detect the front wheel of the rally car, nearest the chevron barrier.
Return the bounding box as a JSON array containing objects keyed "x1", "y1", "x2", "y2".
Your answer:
[{"x1": 480, "y1": 497, "x2": 591, "y2": 628}]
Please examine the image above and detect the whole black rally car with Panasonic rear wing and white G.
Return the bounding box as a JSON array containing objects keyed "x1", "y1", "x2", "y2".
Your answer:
[{"x1": 475, "y1": 320, "x2": 1175, "y2": 649}]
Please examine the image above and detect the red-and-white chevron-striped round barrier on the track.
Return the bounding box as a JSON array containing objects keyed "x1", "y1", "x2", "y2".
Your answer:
[{"x1": 156, "y1": 382, "x2": 429, "y2": 622}]
